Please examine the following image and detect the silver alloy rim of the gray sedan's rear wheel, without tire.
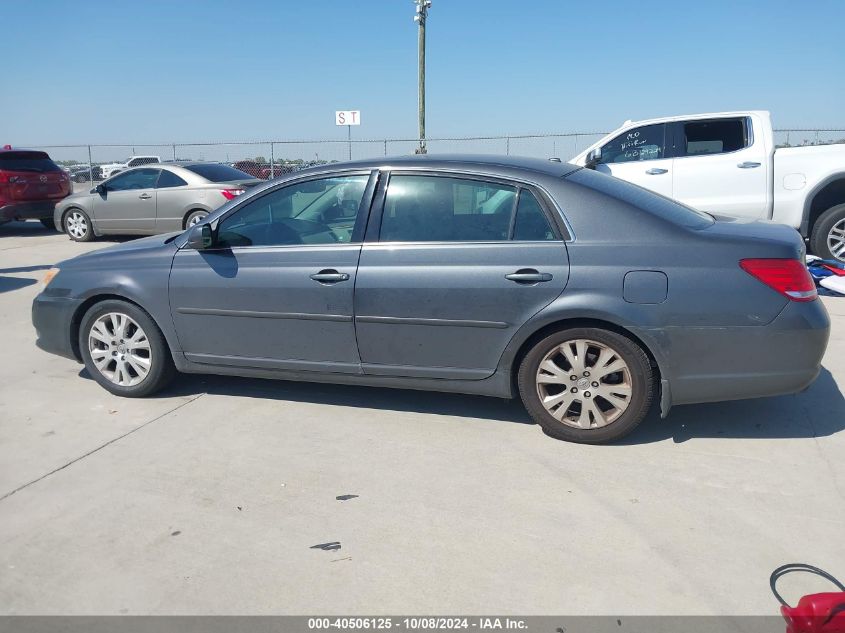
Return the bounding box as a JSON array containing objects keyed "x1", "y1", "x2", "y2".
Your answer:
[{"x1": 536, "y1": 339, "x2": 632, "y2": 429}]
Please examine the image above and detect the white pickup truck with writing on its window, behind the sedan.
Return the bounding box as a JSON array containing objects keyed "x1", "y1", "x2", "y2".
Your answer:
[{"x1": 570, "y1": 111, "x2": 845, "y2": 261}]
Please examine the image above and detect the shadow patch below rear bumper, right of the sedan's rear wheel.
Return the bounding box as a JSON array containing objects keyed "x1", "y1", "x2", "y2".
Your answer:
[{"x1": 619, "y1": 368, "x2": 845, "y2": 445}]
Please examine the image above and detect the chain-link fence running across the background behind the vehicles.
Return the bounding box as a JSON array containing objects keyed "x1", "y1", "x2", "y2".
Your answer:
[{"x1": 28, "y1": 128, "x2": 845, "y2": 189}]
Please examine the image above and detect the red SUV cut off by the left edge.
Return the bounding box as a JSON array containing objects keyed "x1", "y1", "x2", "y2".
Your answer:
[{"x1": 0, "y1": 145, "x2": 71, "y2": 229}]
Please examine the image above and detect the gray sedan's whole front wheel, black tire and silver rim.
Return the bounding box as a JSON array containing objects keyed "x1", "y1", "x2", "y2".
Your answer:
[{"x1": 79, "y1": 299, "x2": 176, "y2": 398}]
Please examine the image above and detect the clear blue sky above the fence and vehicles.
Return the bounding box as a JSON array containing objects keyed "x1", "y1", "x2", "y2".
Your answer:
[{"x1": 0, "y1": 0, "x2": 845, "y2": 145}]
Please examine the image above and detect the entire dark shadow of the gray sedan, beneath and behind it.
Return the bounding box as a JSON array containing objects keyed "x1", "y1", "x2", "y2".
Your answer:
[{"x1": 79, "y1": 368, "x2": 845, "y2": 446}]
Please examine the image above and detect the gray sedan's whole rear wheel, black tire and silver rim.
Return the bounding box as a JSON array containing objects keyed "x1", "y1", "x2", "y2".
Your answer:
[{"x1": 517, "y1": 328, "x2": 654, "y2": 444}]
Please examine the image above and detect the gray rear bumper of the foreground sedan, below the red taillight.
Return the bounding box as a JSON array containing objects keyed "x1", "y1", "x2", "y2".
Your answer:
[{"x1": 637, "y1": 299, "x2": 830, "y2": 410}]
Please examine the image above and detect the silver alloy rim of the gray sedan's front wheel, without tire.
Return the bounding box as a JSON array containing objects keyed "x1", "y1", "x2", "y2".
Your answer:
[{"x1": 88, "y1": 312, "x2": 153, "y2": 387}]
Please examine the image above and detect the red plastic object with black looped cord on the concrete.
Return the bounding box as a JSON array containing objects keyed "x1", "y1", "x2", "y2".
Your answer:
[{"x1": 769, "y1": 563, "x2": 845, "y2": 633}]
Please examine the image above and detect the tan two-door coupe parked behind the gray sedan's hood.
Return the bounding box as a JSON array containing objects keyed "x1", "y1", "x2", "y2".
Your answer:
[{"x1": 51, "y1": 162, "x2": 262, "y2": 242}]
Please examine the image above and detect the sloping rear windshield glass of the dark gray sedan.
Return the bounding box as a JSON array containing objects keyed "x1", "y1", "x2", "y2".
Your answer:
[{"x1": 566, "y1": 169, "x2": 714, "y2": 229}]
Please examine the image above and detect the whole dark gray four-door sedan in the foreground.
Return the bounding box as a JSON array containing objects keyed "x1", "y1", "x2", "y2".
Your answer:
[{"x1": 32, "y1": 156, "x2": 830, "y2": 443}]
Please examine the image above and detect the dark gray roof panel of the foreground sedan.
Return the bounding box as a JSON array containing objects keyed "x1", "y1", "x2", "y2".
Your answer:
[{"x1": 297, "y1": 154, "x2": 580, "y2": 178}]
